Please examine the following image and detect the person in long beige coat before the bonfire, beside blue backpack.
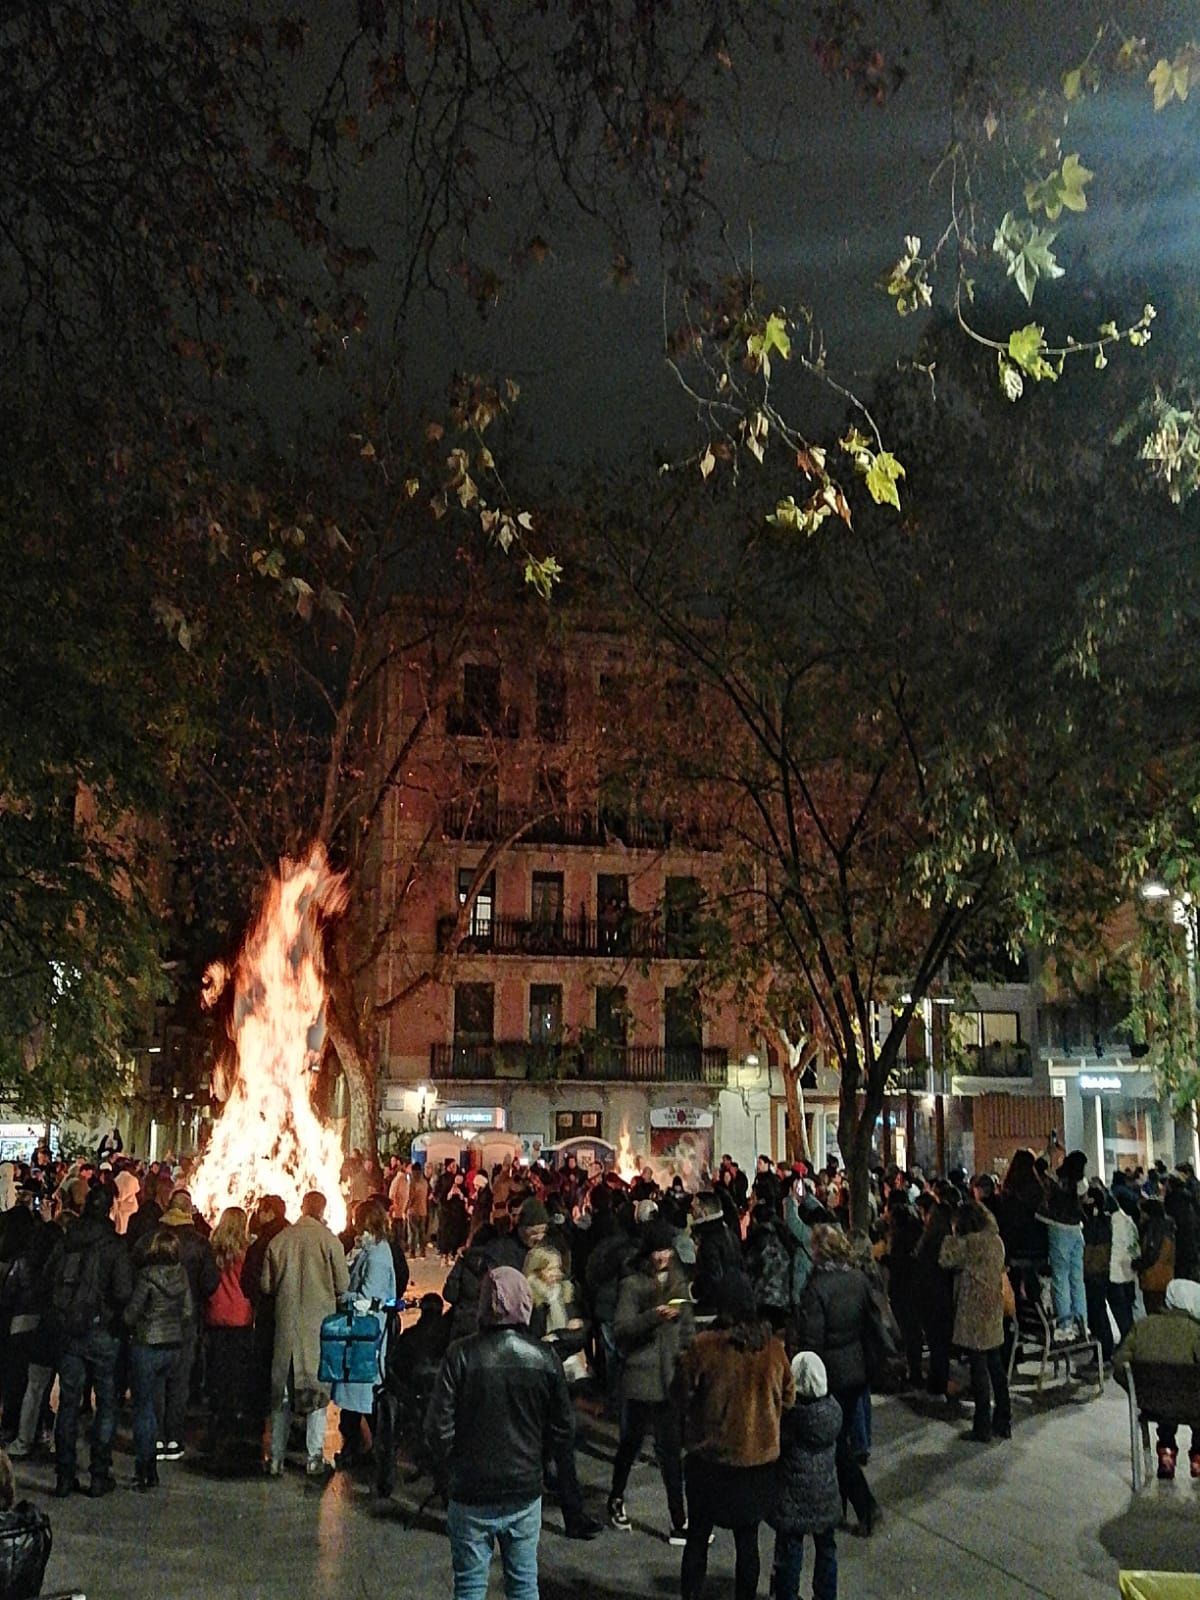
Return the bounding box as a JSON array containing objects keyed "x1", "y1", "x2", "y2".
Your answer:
[{"x1": 262, "y1": 1190, "x2": 350, "y2": 1478}]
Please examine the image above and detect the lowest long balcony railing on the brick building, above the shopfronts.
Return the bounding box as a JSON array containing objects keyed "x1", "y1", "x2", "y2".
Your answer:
[{"x1": 429, "y1": 1042, "x2": 730, "y2": 1090}]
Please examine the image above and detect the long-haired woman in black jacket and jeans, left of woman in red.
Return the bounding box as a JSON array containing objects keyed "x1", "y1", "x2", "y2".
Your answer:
[{"x1": 125, "y1": 1227, "x2": 194, "y2": 1490}]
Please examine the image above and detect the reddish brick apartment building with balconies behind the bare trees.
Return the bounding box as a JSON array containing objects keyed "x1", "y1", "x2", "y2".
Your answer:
[{"x1": 366, "y1": 601, "x2": 782, "y2": 1162}]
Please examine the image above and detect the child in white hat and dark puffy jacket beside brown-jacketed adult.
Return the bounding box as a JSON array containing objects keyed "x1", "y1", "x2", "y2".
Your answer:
[{"x1": 771, "y1": 1350, "x2": 842, "y2": 1600}]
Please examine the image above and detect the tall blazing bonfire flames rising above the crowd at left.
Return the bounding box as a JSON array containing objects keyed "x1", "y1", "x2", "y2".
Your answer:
[{"x1": 192, "y1": 845, "x2": 347, "y2": 1232}]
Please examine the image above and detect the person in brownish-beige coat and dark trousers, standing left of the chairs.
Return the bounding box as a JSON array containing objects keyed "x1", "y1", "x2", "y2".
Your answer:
[{"x1": 938, "y1": 1200, "x2": 1013, "y2": 1445}]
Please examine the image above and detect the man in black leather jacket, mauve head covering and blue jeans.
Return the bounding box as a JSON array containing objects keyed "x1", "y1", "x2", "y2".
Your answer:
[{"x1": 426, "y1": 1267, "x2": 574, "y2": 1600}]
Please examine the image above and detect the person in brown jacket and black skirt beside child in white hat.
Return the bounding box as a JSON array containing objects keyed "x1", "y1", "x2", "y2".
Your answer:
[{"x1": 678, "y1": 1272, "x2": 795, "y2": 1600}]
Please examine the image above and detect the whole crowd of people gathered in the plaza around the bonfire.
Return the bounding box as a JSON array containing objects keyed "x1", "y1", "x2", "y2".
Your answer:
[{"x1": 0, "y1": 1149, "x2": 1200, "y2": 1600}]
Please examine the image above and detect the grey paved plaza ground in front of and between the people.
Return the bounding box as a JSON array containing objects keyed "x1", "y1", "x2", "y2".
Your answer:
[{"x1": 18, "y1": 1264, "x2": 1200, "y2": 1600}]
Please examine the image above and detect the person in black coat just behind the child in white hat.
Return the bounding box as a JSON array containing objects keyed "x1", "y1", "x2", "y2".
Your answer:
[{"x1": 794, "y1": 1226, "x2": 880, "y2": 1534}]
